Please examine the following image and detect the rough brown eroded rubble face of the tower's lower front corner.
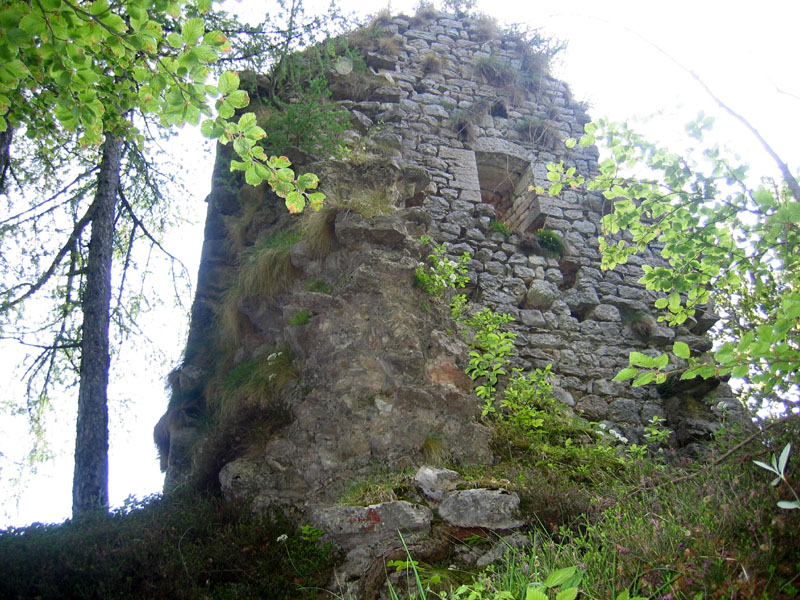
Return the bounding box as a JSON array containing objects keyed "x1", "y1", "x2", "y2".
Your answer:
[{"x1": 216, "y1": 209, "x2": 492, "y2": 505}]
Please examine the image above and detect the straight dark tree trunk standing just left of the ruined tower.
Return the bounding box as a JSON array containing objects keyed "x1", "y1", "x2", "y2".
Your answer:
[{"x1": 72, "y1": 136, "x2": 122, "y2": 517}]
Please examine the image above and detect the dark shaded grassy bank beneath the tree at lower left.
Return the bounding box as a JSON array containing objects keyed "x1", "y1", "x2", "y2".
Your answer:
[{"x1": 0, "y1": 494, "x2": 335, "y2": 600}]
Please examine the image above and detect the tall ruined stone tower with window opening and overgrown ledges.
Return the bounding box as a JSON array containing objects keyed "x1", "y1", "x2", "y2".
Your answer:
[{"x1": 155, "y1": 9, "x2": 736, "y2": 588}]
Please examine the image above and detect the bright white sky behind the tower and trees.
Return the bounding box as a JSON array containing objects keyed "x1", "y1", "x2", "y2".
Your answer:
[{"x1": 0, "y1": 0, "x2": 800, "y2": 527}]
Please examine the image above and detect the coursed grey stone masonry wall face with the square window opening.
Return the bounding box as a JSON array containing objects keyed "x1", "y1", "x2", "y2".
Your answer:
[{"x1": 316, "y1": 11, "x2": 737, "y2": 445}]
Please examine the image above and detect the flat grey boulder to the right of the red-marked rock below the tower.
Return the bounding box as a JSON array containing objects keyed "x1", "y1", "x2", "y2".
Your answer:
[{"x1": 438, "y1": 489, "x2": 524, "y2": 529}]
